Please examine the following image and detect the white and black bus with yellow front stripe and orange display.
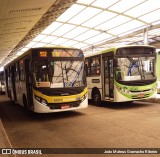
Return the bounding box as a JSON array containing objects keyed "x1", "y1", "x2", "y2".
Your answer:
[{"x1": 4, "y1": 47, "x2": 88, "y2": 113}]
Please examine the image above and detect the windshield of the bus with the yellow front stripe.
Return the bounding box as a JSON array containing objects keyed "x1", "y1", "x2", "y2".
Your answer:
[{"x1": 34, "y1": 59, "x2": 86, "y2": 88}]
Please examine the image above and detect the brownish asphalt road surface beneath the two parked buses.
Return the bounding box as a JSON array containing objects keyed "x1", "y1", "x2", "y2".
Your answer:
[{"x1": 0, "y1": 95, "x2": 160, "y2": 157}]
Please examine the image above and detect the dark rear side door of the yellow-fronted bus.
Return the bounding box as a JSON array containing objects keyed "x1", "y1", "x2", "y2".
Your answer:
[{"x1": 11, "y1": 65, "x2": 17, "y2": 101}]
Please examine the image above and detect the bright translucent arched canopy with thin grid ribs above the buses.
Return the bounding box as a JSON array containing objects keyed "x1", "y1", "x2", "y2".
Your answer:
[{"x1": 0, "y1": 0, "x2": 160, "y2": 67}]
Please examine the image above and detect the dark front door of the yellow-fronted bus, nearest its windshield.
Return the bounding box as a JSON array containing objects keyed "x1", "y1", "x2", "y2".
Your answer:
[{"x1": 25, "y1": 59, "x2": 33, "y2": 108}]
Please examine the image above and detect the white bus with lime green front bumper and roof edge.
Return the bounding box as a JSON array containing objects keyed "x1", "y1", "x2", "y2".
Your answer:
[{"x1": 85, "y1": 45, "x2": 157, "y2": 104}]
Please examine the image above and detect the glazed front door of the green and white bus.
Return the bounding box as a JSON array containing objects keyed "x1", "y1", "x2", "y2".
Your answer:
[{"x1": 103, "y1": 56, "x2": 114, "y2": 100}]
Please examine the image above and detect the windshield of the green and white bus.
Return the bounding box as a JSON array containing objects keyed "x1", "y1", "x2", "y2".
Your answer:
[{"x1": 116, "y1": 56, "x2": 155, "y2": 81}]
